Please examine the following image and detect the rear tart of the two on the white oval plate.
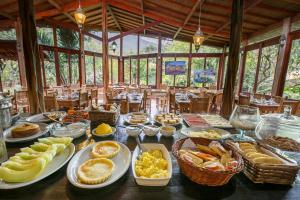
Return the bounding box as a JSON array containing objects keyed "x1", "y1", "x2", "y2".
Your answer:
[{"x1": 91, "y1": 141, "x2": 121, "y2": 158}]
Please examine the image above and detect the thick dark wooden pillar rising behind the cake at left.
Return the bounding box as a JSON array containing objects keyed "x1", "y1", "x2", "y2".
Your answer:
[{"x1": 18, "y1": 0, "x2": 45, "y2": 114}]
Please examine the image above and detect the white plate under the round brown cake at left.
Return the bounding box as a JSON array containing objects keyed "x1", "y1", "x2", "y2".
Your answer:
[{"x1": 3, "y1": 122, "x2": 50, "y2": 143}]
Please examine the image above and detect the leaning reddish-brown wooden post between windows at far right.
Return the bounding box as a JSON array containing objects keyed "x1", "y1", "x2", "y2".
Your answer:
[{"x1": 272, "y1": 17, "x2": 292, "y2": 96}]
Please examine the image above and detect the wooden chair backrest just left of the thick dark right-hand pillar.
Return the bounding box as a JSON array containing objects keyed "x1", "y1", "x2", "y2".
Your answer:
[{"x1": 190, "y1": 97, "x2": 211, "y2": 113}]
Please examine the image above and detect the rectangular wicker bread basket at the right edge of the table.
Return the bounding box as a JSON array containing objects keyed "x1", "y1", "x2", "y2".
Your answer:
[{"x1": 226, "y1": 141, "x2": 299, "y2": 185}]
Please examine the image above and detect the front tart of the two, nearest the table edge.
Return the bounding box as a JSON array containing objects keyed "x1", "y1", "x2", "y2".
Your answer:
[{"x1": 77, "y1": 158, "x2": 115, "y2": 185}]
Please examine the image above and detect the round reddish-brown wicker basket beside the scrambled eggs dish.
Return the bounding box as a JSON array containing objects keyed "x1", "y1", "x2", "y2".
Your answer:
[{"x1": 172, "y1": 138, "x2": 243, "y2": 186}]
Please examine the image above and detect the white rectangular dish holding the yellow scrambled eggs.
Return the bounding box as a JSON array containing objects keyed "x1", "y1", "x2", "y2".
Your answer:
[{"x1": 131, "y1": 143, "x2": 172, "y2": 186}]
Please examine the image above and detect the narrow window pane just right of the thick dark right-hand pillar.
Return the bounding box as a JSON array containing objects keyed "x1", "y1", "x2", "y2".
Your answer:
[{"x1": 242, "y1": 49, "x2": 259, "y2": 93}]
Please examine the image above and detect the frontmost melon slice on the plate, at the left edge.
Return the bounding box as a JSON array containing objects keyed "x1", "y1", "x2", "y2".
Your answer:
[{"x1": 0, "y1": 158, "x2": 46, "y2": 183}]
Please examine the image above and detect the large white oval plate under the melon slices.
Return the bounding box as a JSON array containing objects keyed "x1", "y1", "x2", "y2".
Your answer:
[{"x1": 0, "y1": 143, "x2": 75, "y2": 189}]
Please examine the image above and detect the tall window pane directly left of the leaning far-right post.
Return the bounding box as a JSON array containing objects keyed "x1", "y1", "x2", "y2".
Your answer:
[{"x1": 257, "y1": 45, "x2": 278, "y2": 93}]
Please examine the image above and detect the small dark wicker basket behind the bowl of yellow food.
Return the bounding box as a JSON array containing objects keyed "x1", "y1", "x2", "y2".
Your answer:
[{"x1": 89, "y1": 106, "x2": 120, "y2": 129}]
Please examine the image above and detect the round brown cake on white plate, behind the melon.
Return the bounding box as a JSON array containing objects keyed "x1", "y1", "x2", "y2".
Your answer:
[{"x1": 11, "y1": 123, "x2": 41, "y2": 138}]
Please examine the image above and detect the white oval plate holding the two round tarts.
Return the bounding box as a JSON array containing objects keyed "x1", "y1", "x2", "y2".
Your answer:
[{"x1": 67, "y1": 142, "x2": 131, "y2": 189}]
